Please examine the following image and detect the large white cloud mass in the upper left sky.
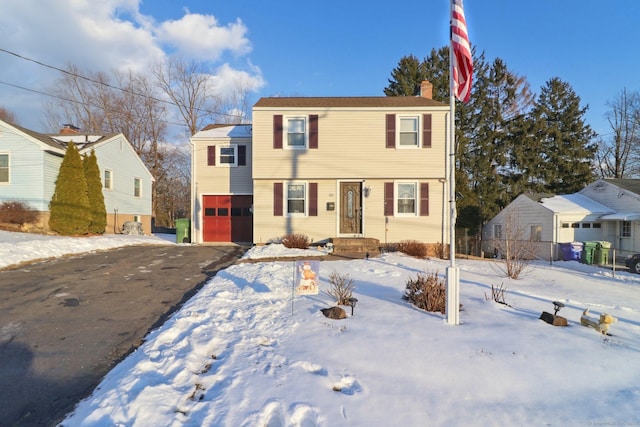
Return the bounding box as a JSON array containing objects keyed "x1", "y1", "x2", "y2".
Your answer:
[{"x1": 0, "y1": 0, "x2": 264, "y2": 131}]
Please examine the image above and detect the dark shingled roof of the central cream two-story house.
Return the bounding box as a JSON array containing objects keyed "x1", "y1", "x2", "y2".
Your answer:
[{"x1": 254, "y1": 96, "x2": 448, "y2": 108}]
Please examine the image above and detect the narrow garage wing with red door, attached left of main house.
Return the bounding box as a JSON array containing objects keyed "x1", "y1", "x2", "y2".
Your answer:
[{"x1": 191, "y1": 125, "x2": 253, "y2": 243}]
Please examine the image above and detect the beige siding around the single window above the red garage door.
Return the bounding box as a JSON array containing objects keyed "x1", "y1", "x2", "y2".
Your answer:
[{"x1": 192, "y1": 139, "x2": 253, "y2": 194}]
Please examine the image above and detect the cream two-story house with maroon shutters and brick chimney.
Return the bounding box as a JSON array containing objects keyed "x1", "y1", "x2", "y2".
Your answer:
[{"x1": 192, "y1": 82, "x2": 449, "y2": 251}]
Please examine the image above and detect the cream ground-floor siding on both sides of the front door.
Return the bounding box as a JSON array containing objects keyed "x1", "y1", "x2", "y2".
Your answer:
[{"x1": 253, "y1": 178, "x2": 447, "y2": 244}]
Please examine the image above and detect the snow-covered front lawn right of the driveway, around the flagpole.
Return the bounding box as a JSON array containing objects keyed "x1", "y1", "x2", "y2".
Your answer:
[{"x1": 0, "y1": 233, "x2": 640, "y2": 427}]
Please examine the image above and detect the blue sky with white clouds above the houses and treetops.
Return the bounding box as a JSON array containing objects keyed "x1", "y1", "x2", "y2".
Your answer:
[{"x1": 0, "y1": 0, "x2": 640, "y2": 139}]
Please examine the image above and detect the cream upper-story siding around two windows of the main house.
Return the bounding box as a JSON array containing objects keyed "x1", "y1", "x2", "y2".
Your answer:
[{"x1": 253, "y1": 108, "x2": 446, "y2": 179}]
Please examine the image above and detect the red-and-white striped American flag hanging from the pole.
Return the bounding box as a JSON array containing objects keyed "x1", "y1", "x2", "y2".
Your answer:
[{"x1": 451, "y1": 0, "x2": 473, "y2": 102}]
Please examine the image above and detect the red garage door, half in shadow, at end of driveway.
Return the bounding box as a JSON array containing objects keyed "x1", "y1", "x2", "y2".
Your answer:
[{"x1": 202, "y1": 196, "x2": 253, "y2": 243}]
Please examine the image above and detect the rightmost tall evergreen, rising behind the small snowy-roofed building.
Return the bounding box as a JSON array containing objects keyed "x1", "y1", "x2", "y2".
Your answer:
[{"x1": 530, "y1": 77, "x2": 597, "y2": 194}]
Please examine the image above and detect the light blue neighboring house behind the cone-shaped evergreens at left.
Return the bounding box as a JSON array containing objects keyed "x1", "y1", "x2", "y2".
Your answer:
[{"x1": 0, "y1": 120, "x2": 154, "y2": 234}]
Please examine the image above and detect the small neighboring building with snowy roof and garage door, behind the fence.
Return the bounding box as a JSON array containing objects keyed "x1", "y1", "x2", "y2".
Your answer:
[{"x1": 482, "y1": 193, "x2": 615, "y2": 260}]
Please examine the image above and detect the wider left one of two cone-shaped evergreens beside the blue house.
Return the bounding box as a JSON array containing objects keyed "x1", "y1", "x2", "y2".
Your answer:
[{"x1": 49, "y1": 142, "x2": 90, "y2": 235}]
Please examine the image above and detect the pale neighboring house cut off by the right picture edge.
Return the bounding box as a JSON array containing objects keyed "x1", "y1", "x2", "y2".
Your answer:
[{"x1": 580, "y1": 179, "x2": 640, "y2": 256}]
